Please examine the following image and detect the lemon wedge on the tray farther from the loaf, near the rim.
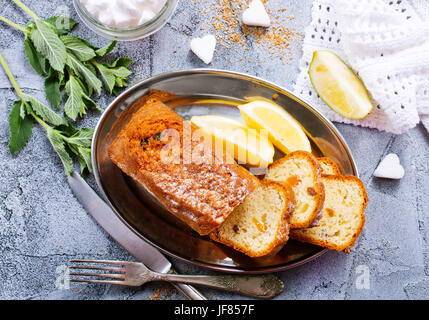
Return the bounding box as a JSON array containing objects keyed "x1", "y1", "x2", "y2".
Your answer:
[{"x1": 238, "y1": 100, "x2": 311, "y2": 153}]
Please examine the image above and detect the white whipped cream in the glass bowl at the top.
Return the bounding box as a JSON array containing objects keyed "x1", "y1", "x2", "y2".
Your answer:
[{"x1": 80, "y1": 0, "x2": 167, "y2": 29}]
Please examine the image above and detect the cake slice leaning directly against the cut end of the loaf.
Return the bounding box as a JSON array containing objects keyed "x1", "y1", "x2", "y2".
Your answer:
[{"x1": 210, "y1": 181, "x2": 294, "y2": 257}]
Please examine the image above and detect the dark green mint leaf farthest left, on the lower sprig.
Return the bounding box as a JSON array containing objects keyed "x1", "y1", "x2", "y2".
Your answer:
[{"x1": 9, "y1": 100, "x2": 33, "y2": 156}]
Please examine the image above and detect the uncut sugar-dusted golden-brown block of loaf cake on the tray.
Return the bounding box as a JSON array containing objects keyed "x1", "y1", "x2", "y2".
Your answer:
[{"x1": 108, "y1": 96, "x2": 259, "y2": 235}]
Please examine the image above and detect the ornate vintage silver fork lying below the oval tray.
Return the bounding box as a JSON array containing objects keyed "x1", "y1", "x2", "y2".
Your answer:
[{"x1": 69, "y1": 260, "x2": 284, "y2": 299}]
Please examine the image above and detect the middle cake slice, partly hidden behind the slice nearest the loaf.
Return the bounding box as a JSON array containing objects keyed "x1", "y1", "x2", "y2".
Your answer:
[{"x1": 265, "y1": 151, "x2": 325, "y2": 229}]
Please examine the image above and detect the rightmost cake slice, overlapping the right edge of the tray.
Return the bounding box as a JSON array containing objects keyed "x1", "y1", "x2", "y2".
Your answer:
[{"x1": 291, "y1": 175, "x2": 368, "y2": 253}]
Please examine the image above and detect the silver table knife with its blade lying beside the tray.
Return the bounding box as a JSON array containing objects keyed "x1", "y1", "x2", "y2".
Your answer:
[{"x1": 67, "y1": 172, "x2": 207, "y2": 300}]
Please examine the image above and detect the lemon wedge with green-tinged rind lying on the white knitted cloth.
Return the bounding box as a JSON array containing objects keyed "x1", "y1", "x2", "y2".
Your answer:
[{"x1": 309, "y1": 51, "x2": 372, "y2": 119}]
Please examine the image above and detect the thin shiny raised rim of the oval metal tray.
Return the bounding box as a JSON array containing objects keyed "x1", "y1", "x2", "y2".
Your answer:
[{"x1": 91, "y1": 68, "x2": 359, "y2": 274}]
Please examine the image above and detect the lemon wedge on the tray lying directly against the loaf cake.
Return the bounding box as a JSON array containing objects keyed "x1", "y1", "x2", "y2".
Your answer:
[{"x1": 191, "y1": 116, "x2": 274, "y2": 166}]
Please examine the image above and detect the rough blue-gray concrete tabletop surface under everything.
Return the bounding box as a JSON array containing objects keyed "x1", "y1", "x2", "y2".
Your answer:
[{"x1": 0, "y1": 0, "x2": 429, "y2": 299}]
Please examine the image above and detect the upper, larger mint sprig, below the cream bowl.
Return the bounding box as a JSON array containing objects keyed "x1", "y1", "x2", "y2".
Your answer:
[{"x1": 0, "y1": 0, "x2": 132, "y2": 121}]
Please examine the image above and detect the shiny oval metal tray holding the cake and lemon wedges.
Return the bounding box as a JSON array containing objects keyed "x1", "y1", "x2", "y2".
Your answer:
[{"x1": 92, "y1": 69, "x2": 358, "y2": 273}]
